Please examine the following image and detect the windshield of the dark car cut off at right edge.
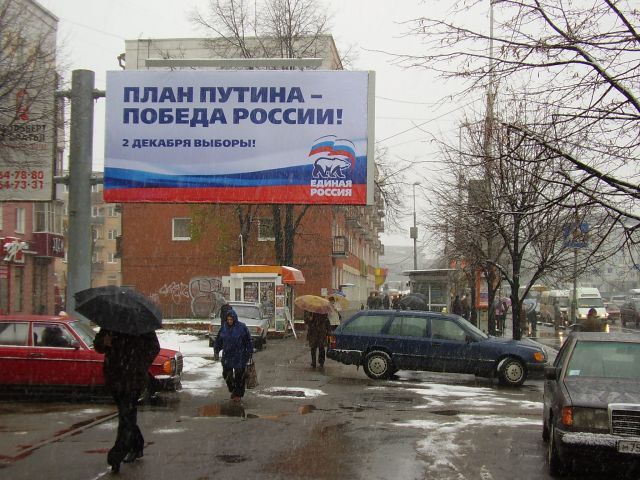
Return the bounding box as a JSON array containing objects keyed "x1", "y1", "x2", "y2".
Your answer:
[{"x1": 566, "y1": 341, "x2": 640, "y2": 380}]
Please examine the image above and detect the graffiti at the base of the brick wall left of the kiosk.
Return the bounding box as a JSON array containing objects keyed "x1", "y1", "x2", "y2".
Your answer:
[{"x1": 157, "y1": 277, "x2": 226, "y2": 318}]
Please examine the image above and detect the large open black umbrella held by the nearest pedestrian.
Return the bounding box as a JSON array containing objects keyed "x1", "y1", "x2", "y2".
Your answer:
[{"x1": 74, "y1": 285, "x2": 162, "y2": 335}]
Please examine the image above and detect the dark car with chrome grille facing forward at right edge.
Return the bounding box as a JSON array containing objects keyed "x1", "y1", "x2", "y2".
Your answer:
[{"x1": 542, "y1": 332, "x2": 640, "y2": 478}]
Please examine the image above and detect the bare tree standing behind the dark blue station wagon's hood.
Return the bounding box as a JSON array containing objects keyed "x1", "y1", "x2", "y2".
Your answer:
[{"x1": 430, "y1": 112, "x2": 610, "y2": 339}]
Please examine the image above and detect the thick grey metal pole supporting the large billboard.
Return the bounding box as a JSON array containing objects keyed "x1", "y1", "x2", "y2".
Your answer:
[{"x1": 64, "y1": 70, "x2": 104, "y2": 313}]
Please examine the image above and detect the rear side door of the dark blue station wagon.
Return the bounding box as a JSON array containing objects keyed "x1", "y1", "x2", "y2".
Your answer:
[{"x1": 387, "y1": 314, "x2": 430, "y2": 370}]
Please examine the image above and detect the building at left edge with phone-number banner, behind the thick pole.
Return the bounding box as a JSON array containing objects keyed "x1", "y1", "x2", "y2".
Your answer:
[{"x1": 0, "y1": 0, "x2": 64, "y2": 314}]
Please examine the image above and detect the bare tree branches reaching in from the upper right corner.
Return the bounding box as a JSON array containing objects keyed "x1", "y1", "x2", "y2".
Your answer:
[{"x1": 397, "y1": 0, "x2": 640, "y2": 242}]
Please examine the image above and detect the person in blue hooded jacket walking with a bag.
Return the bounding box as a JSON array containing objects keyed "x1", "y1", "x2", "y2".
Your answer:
[{"x1": 213, "y1": 308, "x2": 253, "y2": 402}]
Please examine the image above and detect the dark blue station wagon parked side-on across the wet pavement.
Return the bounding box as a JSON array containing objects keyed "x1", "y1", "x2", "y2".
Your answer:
[{"x1": 327, "y1": 310, "x2": 548, "y2": 386}]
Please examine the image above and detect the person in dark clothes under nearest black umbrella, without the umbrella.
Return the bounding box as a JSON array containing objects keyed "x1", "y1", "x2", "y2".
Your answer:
[{"x1": 93, "y1": 328, "x2": 160, "y2": 473}]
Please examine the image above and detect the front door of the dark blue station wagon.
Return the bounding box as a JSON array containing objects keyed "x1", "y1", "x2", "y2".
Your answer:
[{"x1": 430, "y1": 317, "x2": 474, "y2": 373}]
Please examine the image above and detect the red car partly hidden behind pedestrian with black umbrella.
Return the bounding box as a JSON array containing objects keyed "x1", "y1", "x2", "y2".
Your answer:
[{"x1": 0, "y1": 315, "x2": 182, "y2": 392}]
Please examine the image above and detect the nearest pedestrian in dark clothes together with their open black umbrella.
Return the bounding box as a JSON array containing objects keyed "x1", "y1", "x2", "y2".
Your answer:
[{"x1": 74, "y1": 285, "x2": 162, "y2": 473}]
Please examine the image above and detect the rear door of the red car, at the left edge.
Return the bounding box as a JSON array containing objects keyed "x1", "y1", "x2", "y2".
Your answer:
[{"x1": 0, "y1": 321, "x2": 31, "y2": 385}]
